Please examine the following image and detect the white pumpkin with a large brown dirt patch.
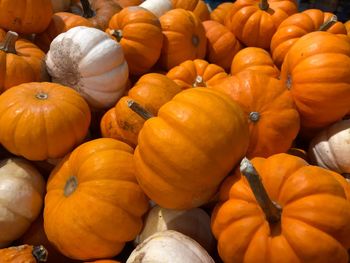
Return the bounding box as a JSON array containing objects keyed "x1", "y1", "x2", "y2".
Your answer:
[{"x1": 45, "y1": 26, "x2": 129, "y2": 109}]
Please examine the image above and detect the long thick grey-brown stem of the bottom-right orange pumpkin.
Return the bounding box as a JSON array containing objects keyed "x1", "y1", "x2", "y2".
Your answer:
[{"x1": 239, "y1": 158, "x2": 282, "y2": 224}]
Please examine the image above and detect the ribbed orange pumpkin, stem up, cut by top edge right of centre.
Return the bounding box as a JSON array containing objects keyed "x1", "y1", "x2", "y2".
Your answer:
[{"x1": 225, "y1": 0, "x2": 298, "y2": 49}]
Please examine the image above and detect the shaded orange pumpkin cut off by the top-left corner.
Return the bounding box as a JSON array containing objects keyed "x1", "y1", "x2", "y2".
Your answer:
[{"x1": 0, "y1": 0, "x2": 53, "y2": 34}]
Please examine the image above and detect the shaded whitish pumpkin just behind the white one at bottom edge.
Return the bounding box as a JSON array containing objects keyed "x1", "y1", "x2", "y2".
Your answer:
[{"x1": 134, "y1": 205, "x2": 216, "y2": 252}]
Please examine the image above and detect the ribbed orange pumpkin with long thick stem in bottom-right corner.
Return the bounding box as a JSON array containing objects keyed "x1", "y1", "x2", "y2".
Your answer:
[{"x1": 212, "y1": 153, "x2": 350, "y2": 263}]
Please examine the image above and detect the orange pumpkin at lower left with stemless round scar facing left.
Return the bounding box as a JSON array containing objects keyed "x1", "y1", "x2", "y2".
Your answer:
[{"x1": 44, "y1": 138, "x2": 148, "y2": 260}]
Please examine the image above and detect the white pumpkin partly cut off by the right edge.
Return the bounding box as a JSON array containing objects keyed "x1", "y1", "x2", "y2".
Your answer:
[{"x1": 309, "y1": 120, "x2": 350, "y2": 174}]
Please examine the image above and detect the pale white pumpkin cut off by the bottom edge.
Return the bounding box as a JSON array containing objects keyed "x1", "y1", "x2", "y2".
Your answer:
[{"x1": 126, "y1": 230, "x2": 214, "y2": 263}]
